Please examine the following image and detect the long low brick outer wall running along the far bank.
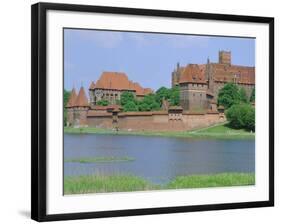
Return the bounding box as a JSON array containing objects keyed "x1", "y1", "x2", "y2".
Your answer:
[{"x1": 84, "y1": 111, "x2": 225, "y2": 131}]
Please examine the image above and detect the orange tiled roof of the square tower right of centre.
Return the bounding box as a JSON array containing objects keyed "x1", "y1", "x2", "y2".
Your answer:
[{"x1": 179, "y1": 64, "x2": 206, "y2": 84}]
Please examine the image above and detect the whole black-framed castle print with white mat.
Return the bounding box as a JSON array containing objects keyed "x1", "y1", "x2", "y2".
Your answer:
[{"x1": 31, "y1": 3, "x2": 274, "y2": 221}]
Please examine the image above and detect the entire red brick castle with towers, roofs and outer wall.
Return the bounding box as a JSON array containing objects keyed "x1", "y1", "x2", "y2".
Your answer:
[{"x1": 66, "y1": 51, "x2": 255, "y2": 131}]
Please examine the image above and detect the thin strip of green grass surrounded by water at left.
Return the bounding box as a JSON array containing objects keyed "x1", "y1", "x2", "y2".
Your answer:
[{"x1": 65, "y1": 156, "x2": 135, "y2": 163}]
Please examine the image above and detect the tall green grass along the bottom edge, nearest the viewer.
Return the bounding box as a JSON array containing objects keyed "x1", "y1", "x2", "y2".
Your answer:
[{"x1": 64, "y1": 173, "x2": 255, "y2": 194}]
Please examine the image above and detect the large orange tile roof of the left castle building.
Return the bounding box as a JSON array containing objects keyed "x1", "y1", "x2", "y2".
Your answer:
[{"x1": 90, "y1": 72, "x2": 152, "y2": 96}]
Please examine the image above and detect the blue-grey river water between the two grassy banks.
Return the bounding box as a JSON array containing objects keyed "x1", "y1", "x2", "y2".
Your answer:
[{"x1": 64, "y1": 134, "x2": 255, "y2": 183}]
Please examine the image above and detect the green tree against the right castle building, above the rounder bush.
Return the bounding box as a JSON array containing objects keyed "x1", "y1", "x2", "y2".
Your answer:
[{"x1": 218, "y1": 83, "x2": 240, "y2": 109}]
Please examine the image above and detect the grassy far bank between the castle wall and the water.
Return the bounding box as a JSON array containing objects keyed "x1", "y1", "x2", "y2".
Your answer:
[{"x1": 64, "y1": 124, "x2": 255, "y2": 139}]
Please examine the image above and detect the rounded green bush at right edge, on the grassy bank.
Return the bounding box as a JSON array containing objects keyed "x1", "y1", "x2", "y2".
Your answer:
[{"x1": 226, "y1": 104, "x2": 255, "y2": 131}]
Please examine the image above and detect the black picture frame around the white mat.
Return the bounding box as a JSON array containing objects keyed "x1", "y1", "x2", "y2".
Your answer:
[{"x1": 31, "y1": 3, "x2": 274, "y2": 221}]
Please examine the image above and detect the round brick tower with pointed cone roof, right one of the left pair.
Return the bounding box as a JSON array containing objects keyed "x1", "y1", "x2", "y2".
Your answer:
[{"x1": 73, "y1": 87, "x2": 89, "y2": 127}]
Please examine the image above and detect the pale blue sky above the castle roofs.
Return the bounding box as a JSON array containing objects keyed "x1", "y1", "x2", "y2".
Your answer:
[{"x1": 64, "y1": 29, "x2": 255, "y2": 90}]
